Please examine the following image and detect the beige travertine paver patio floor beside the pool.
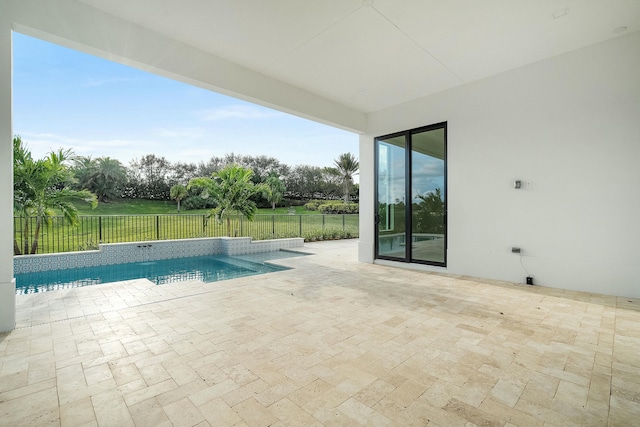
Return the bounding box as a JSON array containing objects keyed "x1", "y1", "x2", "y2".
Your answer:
[{"x1": 0, "y1": 241, "x2": 640, "y2": 426}]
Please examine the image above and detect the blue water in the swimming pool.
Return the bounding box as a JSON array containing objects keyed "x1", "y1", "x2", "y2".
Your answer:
[{"x1": 16, "y1": 251, "x2": 304, "y2": 294}]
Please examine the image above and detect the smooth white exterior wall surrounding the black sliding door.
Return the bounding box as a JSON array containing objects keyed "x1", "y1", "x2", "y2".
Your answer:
[{"x1": 360, "y1": 32, "x2": 640, "y2": 297}]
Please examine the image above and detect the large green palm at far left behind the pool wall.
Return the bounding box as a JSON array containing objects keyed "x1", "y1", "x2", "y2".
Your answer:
[{"x1": 13, "y1": 136, "x2": 98, "y2": 255}]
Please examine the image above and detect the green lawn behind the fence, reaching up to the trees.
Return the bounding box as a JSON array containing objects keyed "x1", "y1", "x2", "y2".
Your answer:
[{"x1": 14, "y1": 200, "x2": 359, "y2": 254}]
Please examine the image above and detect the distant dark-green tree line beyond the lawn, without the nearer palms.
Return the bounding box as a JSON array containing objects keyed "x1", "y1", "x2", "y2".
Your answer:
[{"x1": 71, "y1": 153, "x2": 359, "y2": 209}]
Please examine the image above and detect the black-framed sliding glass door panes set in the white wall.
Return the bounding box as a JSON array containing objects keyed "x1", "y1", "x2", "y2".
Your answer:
[{"x1": 376, "y1": 123, "x2": 447, "y2": 266}]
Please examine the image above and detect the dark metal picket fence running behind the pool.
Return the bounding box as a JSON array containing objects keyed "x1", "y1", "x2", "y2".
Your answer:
[{"x1": 13, "y1": 214, "x2": 358, "y2": 254}]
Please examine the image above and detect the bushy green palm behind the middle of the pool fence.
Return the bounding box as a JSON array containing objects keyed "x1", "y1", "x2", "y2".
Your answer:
[{"x1": 187, "y1": 164, "x2": 262, "y2": 237}]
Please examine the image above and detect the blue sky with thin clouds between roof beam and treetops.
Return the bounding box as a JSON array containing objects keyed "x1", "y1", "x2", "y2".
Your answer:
[{"x1": 13, "y1": 33, "x2": 358, "y2": 166}]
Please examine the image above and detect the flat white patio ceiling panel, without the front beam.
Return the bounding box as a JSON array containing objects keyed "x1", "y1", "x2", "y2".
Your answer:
[{"x1": 79, "y1": 0, "x2": 640, "y2": 113}]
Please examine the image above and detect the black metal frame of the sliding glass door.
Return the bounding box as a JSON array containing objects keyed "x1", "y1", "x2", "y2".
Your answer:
[{"x1": 373, "y1": 122, "x2": 449, "y2": 267}]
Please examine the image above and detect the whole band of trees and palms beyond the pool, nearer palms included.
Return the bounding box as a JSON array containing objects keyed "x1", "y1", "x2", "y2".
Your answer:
[{"x1": 13, "y1": 136, "x2": 359, "y2": 255}]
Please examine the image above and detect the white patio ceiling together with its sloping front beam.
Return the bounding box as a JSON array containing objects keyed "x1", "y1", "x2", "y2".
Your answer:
[{"x1": 7, "y1": 0, "x2": 640, "y2": 134}]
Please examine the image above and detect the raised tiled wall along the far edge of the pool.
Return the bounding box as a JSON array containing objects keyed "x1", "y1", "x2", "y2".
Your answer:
[{"x1": 13, "y1": 237, "x2": 304, "y2": 274}]
